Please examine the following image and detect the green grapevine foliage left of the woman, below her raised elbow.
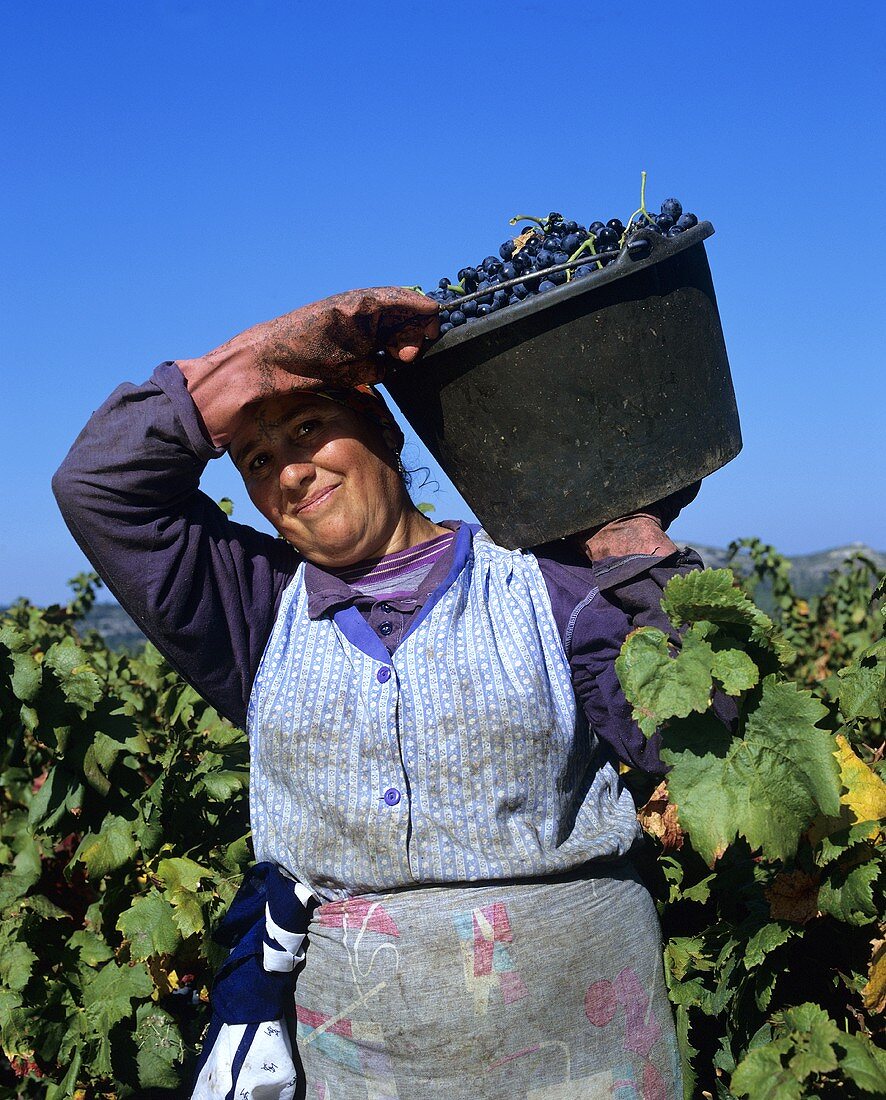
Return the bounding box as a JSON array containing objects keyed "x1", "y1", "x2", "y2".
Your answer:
[{"x1": 0, "y1": 576, "x2": 251, "y2": 1100}]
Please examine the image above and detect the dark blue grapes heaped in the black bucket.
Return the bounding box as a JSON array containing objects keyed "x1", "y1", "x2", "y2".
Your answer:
[{"x1": 426, "y1": 198, "x2": 698, "y2": 333}]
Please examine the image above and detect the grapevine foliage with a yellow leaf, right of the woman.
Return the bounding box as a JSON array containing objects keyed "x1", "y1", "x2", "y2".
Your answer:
[{"x1": 616, "y1": 539, "x2": 886, "y2": 1100}]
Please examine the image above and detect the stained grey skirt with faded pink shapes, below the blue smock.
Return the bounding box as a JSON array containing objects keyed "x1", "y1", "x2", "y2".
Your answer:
[{"x1": 296, "y1": 861, "x2": 682, "y2": 1100}]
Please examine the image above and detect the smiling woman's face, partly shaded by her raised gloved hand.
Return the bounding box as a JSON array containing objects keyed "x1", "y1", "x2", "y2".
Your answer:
[{"x1": 230, "y1": 394, "x2": 415, "y2": 567}]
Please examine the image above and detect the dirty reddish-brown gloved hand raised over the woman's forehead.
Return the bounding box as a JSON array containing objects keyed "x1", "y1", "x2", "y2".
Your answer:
[{"x1": 177, "y1": 286, "x2": 440, "y2": 447}]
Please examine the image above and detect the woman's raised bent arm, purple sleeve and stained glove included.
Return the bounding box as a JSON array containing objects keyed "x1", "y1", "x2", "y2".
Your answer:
[{"x1": 53, "y1": 287, "x2": 438, "y2": 725}]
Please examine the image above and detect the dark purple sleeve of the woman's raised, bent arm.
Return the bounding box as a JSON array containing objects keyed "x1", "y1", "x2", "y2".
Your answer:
[{"x1": 53, "y1": 363, "x2": 297, "y2": 724}]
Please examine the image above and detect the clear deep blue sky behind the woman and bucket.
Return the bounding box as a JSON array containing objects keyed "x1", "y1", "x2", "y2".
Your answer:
[{"x1": 0, "y1": 0, "x2": 886, "y2": 604}]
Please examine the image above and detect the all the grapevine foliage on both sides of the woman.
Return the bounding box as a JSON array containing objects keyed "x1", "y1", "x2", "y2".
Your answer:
[{"x1": 0, "y1": 540, "x2": 886, "y2": 1100}]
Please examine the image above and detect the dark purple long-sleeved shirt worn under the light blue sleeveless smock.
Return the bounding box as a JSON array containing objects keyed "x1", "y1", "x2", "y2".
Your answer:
[{"x1": 53, "y1": 363, "x2": 701, "y2": 772}]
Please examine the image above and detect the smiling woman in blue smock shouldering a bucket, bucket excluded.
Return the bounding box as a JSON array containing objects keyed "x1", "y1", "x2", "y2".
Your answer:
[{"x1": 54, "y1": 288, "x2": 699, "y2": 1100}]
